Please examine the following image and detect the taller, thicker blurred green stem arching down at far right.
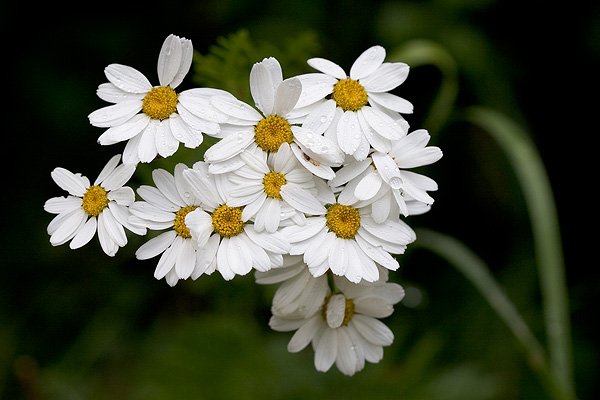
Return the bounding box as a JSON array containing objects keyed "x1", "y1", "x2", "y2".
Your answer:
[{"x1": 465, "y1": 107, "x2": 574, "y2": 397}]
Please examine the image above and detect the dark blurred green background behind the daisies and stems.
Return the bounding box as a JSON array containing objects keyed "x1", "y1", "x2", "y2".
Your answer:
[{"x1": 0, "y1": 0, "x2": 600, "y2": 400}]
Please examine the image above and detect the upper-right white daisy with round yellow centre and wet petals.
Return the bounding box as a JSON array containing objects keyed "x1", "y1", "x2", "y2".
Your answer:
[{"x1": 297, "y1": 46, "x2": 413, "y2": 160}]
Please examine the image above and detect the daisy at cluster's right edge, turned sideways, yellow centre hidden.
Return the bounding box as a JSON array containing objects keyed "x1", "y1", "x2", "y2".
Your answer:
[{"x1": 329, "y1": 129, "x2": 442, "y2": 217}]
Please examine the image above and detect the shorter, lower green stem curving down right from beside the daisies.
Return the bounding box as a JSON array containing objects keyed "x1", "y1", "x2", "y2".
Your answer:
[{"x1": 415, "y1": 229, "x2": 574, "y2": 400}]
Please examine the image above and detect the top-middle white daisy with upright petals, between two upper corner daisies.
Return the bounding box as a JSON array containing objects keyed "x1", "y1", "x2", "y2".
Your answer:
[{"x1": 204, "y1": 57, "x2": 344, "y2": 179}]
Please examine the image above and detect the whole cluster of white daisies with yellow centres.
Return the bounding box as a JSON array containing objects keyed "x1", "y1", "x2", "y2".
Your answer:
[{"x1": 44, "y1": 35, "x2": 442, "y2": 375}]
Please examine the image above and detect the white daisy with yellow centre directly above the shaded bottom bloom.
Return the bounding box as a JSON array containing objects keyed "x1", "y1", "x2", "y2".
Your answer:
[{"x1": 281, "y1": 199, "x2": 416, "y2": 283}]
